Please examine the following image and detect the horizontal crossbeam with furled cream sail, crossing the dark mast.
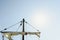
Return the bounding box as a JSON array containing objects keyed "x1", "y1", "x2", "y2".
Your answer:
[{"x1": 1, "y1": 31, "x2": 40, "y2": 37}]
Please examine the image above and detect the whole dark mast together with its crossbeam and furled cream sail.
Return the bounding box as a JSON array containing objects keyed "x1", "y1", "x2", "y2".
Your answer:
[{"x1": 1, "y1": 18, "x2": 40, "y2": 40}]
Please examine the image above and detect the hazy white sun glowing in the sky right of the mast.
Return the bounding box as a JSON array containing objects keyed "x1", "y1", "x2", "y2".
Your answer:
[{"x1": 32, "y1": 14, "x2": 47, "y2": 26}]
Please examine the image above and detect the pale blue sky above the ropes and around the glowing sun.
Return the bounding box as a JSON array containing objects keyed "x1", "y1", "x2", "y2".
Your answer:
[{"x1": 0, "y1": 0, "x2": 60, "y2": 40}]
